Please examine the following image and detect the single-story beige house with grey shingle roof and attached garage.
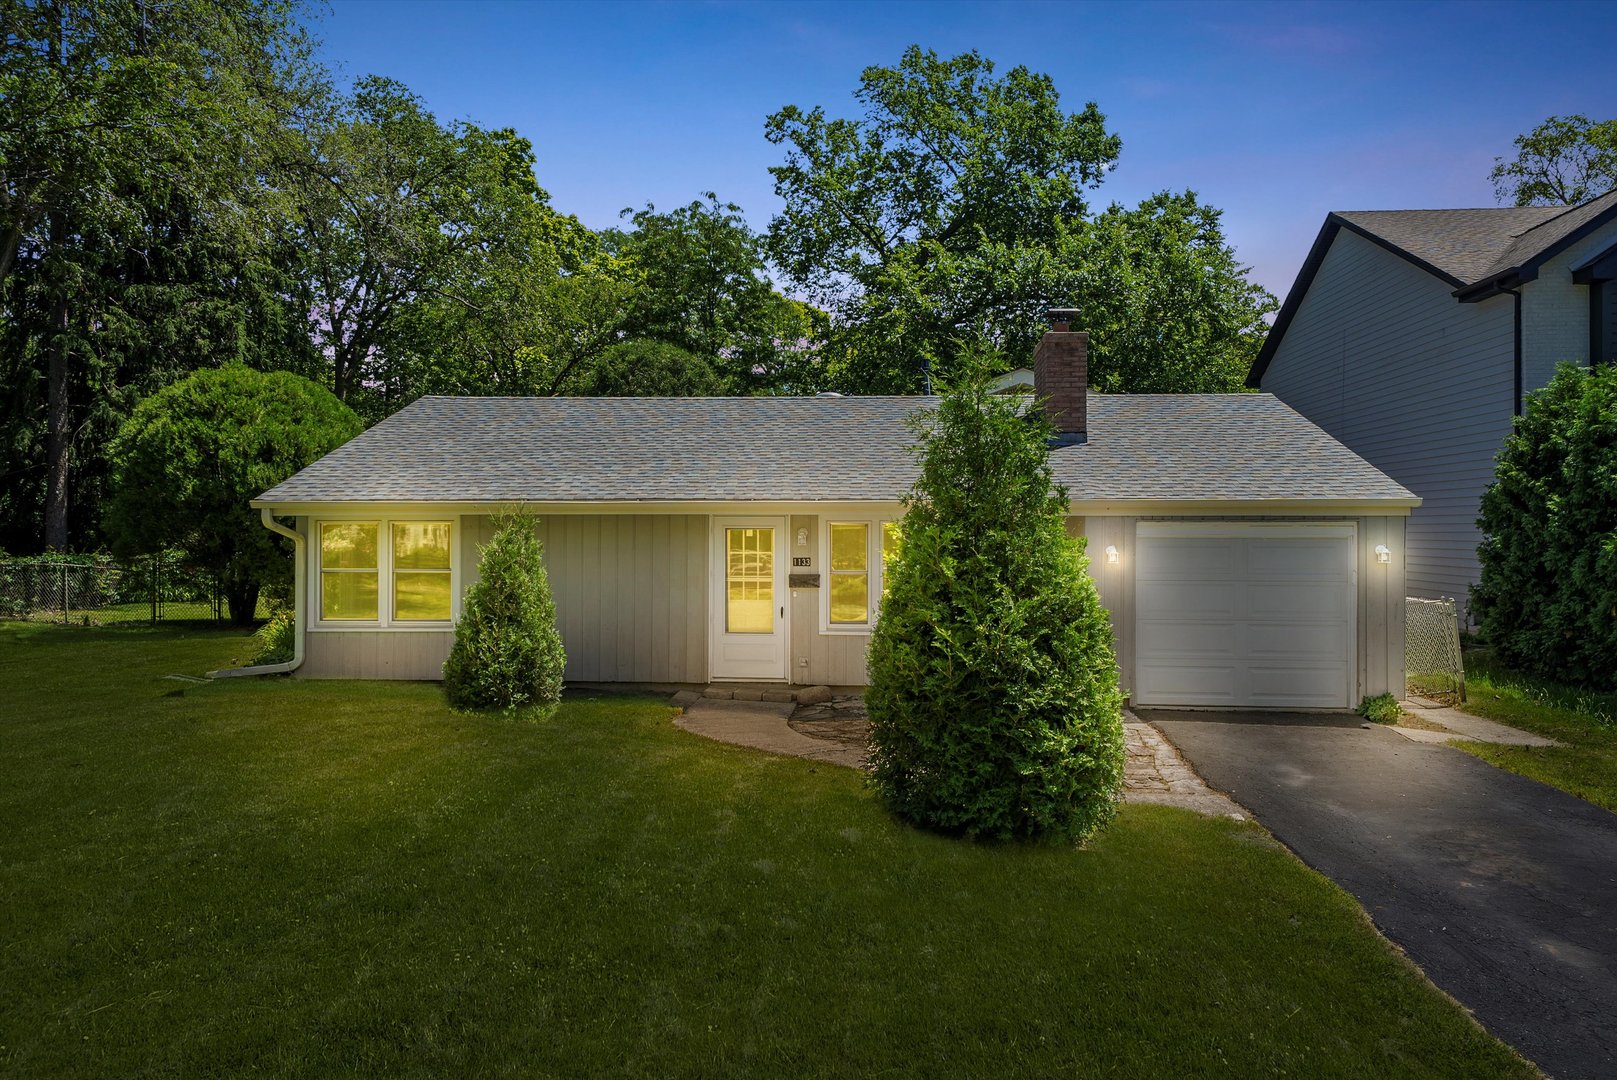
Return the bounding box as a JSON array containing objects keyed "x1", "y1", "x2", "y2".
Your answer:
[{"x1": 252, "y1": 310, "x2": 1420, "y2": 708}]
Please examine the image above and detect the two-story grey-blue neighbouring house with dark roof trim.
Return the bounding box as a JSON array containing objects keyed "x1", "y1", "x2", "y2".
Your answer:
[{"x1": 1247, "y1": 192, "x2": 1617, "y2": 620}]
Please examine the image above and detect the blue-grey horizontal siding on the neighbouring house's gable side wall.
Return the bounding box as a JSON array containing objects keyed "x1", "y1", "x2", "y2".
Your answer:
[{"x1": 1263, "y1": 228, "x2": 1515, "y2": 605}]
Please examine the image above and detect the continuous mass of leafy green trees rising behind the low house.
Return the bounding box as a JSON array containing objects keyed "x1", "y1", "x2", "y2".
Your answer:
[{"x1": 0, "y1": 23, "x2": 1273, "y2": 551}]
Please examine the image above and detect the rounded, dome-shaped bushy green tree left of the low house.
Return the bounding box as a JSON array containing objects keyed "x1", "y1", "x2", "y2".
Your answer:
[{"x1": 105, "y1": 364, "x2": 364, "y2": 622}]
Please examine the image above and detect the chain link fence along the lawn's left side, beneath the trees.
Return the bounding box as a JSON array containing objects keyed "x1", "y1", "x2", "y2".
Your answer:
[{"x1": 0, "y1": 555, "x2": 255, "y2": 626}]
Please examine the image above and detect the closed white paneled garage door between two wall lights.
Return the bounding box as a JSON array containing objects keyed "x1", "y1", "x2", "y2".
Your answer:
[{"x1": 1134, "y1": 522, "x2": 1357, "y2": 708}]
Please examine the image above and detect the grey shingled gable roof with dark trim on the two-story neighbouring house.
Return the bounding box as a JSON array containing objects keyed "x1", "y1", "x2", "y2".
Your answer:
[{"x1": 1247, "y1": 191, "x2": 1617, "y2": 388}]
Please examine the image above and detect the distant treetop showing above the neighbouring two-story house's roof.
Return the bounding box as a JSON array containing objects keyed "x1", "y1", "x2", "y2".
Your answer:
[{"x1": 1488, "y1": 113, "x2": 1617, "y2": 207}]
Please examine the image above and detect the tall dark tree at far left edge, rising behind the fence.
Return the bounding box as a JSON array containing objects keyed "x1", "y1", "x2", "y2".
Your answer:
[{"x1": 0, "y1": 0, "x2": 322, "y2": 550}]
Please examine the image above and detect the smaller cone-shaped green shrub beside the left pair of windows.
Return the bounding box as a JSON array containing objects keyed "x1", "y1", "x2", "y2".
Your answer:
[{"x1": 443, "y1": 514, "x2": 568, "y2": 710}]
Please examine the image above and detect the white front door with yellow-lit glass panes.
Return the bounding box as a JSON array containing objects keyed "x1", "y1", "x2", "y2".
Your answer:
[{"x1": 710, "y1": 517, "x2": 787, "y2": 679}]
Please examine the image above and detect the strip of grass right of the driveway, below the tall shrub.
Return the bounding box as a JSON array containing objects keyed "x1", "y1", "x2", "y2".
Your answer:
[{"x1": 1455, "y1": 650, "x2": 1617, "y2": 812}]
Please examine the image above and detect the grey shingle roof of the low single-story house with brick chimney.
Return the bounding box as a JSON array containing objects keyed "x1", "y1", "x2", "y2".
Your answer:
[{"x1": 254, "y1": 394, "x2": 1420, "y2": 508}]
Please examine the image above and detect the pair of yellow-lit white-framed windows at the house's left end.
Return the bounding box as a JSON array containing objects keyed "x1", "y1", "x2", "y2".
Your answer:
[{"x1": 319, "y1": 521, "x2": 454, "y2": 626}]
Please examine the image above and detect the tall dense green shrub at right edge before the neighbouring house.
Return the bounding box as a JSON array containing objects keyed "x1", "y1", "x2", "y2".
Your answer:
[{"x1": 1471, "y1": 364, "x2": 1617, "y2": 690}]
